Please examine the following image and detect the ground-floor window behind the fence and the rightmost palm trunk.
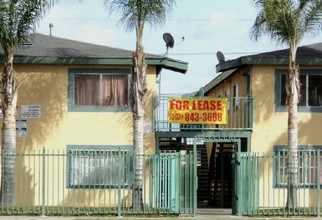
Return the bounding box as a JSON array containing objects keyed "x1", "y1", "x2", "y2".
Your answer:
[{"x1": 274, "y1": 146, "x2": 322, "y2": 187}]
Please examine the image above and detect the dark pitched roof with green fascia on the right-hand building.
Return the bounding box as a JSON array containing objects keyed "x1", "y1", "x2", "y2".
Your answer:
[{"x1": 216, "y1": 43, "x2": 322, "y2": 72}]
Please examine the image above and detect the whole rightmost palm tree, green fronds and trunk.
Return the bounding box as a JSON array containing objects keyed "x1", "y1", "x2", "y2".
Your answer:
[{"x1": 251, "y1": 0, "x2": 322, "y2": 209}]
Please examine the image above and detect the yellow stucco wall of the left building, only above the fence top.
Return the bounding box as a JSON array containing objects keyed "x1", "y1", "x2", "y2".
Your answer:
[{"x1": 3, "y1": 65, "x2": 156, "y2": 151}]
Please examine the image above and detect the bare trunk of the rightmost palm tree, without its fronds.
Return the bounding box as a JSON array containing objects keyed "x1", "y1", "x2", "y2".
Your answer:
[{"x1": 286, "y1": 47, "x2": 300, "y2": 209}]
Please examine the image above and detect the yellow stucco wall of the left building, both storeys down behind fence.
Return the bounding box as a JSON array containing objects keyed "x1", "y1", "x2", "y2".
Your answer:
[{"x1": 0, "y1": 65, "x2": 157, "y2": 206}]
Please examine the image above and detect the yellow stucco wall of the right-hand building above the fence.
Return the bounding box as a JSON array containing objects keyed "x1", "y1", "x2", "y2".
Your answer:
[{"x1": 251, "y1": 66, "x2": 322, "y2": 153}]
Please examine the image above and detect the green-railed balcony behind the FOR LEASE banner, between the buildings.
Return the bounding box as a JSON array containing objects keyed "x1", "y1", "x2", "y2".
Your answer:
[{"x1": 153, "y1": 95, "x2": 254, "y2": 132}]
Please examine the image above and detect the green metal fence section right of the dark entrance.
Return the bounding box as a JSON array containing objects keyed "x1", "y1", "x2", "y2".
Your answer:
[{"x1": 233, "y1": 150, "x2": 322, "y2": 217}]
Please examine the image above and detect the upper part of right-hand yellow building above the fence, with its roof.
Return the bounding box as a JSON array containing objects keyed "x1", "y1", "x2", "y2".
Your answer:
[{"x1": 213, "y1": 43, "x2": 322, "y2": 154}]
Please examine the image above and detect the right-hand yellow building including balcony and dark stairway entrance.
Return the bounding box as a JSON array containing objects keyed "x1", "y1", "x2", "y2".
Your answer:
[{"x1": 156, "y1": 43, "x2": 322, "y2": 213}]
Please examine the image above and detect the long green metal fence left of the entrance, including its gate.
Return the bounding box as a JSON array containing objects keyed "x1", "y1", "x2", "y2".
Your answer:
[{"x1": 0, "y1": 148, "x2": 196, "y2": 216}]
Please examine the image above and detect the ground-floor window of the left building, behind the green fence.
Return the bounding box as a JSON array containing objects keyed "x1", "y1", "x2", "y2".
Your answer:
[{"x1": 67, "y1": 146, "x2": 133, "y2": 188}]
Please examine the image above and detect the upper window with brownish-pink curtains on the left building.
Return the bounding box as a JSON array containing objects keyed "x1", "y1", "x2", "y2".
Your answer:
[{"x1": 68, "y1": 69, "x2": 130, "y2": 111}]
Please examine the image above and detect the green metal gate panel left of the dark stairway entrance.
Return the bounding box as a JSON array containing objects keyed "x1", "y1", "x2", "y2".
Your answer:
[{"x1": 151, "y1": 147, "x2": 197, "y2": 215}]
